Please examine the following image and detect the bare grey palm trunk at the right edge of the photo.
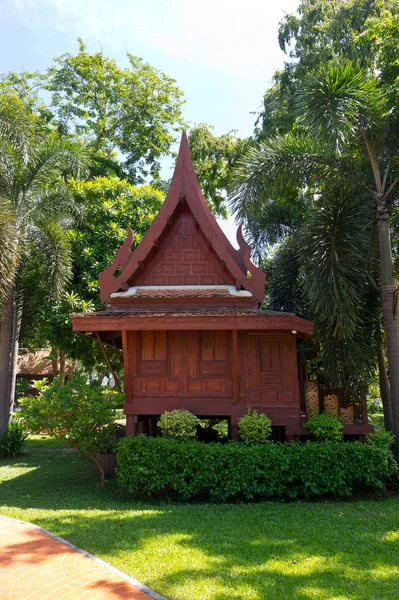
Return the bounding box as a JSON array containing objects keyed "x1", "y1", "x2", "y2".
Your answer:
[{"x1": 377, "y1": 203, "x2": 399, "y2": 456}]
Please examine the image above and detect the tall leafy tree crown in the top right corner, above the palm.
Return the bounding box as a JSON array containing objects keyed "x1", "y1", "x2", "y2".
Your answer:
[{"x1": 256, "y1": 0, "x2": 399, "y2": 139}]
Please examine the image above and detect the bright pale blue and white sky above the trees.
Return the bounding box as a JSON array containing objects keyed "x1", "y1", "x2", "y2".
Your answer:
[{"x1": 0, "y1": 0, "x2": 299, "y2": 241}]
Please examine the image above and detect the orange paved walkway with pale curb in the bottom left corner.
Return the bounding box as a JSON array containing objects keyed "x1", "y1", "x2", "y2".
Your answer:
[{"x1": 0, "y1": 517, "x2": 166, "y2": 600}]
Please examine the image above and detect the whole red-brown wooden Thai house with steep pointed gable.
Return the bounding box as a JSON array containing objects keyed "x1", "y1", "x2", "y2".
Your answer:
[{"x1": 72, "y1": 134, "x2": 374, "y2": 439}]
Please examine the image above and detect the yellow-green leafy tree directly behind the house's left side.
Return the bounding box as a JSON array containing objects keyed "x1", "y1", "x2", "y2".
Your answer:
[{"x1": 18, "y1": 177, "x2": 163, "y2": 373}]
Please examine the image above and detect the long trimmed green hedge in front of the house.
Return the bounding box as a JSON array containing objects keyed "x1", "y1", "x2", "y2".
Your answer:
[{"x1": 117, "y1": 435, "x2": 397, "y2": 502}]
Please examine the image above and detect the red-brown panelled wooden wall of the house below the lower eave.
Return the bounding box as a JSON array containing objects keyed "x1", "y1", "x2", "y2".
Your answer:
[{"x1": 126, "y1": 331, "x2": 300, "y2": 426}]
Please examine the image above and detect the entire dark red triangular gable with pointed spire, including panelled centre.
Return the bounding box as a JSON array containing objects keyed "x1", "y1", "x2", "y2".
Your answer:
[{"x1": 99, "y1": 133, "x2": 265, "y2": 308}]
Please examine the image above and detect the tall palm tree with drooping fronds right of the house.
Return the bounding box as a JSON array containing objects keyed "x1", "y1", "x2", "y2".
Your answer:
[{"x1": 231, "y1": 63, "x2": 399, "y2": 454}]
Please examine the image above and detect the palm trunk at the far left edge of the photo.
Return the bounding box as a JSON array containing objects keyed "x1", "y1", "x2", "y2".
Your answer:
[{"x1": 0, "y1": 286, "x2": 15, "y2": 435}]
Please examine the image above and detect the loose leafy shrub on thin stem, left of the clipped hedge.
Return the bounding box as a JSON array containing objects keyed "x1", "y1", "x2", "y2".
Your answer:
[{"x1": 20, "y1": 373, "x2": 123, "y2": 481}]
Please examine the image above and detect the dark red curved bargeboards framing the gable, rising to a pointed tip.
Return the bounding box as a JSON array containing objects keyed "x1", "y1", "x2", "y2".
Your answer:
[{"x1": 99, "y1": 133, "x2": 265, "y2": 303}]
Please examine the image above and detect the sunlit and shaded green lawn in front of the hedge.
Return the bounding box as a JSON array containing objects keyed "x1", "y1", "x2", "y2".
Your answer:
[{"x1": 0, "y1": 438, "x2": 399, "y2": 600}]
